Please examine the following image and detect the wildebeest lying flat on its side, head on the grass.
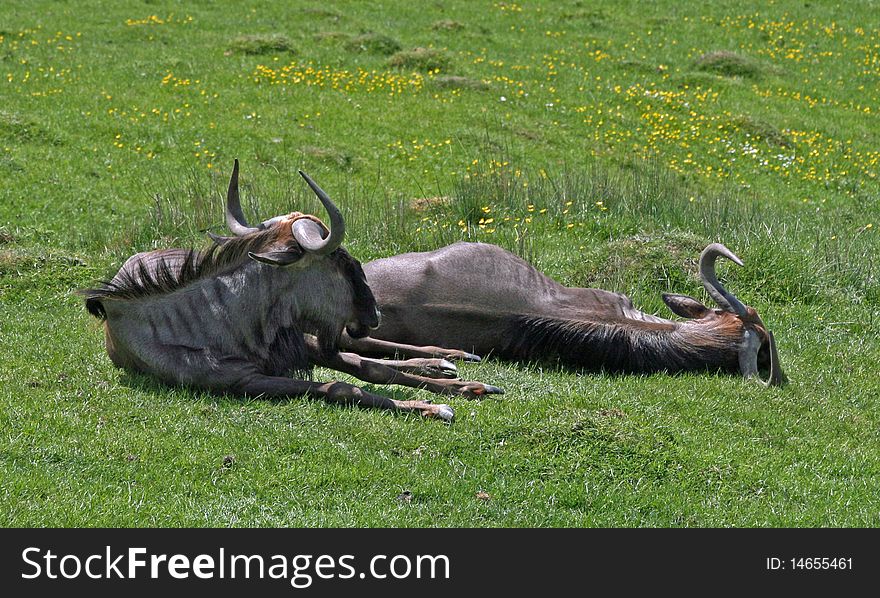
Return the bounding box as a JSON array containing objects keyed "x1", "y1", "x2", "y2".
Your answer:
[{"x1": 343, "y1": 243, "x2": 784, "y2": 385}]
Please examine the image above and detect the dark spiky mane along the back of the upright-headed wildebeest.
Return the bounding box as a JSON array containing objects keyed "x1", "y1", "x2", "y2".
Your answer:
[{"x1": 79, "y1": 228, "x2": 277, "y2": 319}]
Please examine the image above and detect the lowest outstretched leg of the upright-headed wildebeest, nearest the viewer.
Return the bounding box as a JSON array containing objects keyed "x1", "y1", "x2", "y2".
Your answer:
[{"x1": 236, "y1": 374, "x2": 455, "y2": 421}]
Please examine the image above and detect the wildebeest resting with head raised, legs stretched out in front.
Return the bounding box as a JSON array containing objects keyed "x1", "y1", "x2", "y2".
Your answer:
[{"x1": 83, "y1": 160, "x2": 501, "y2": 420}]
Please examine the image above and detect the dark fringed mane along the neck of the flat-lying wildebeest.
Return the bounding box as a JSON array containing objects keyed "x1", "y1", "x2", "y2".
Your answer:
[{"x1": 499, "y1": 316, "x2": 739, "y2": 373}]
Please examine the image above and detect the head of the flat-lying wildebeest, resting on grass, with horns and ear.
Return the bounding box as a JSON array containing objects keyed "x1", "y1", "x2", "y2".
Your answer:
[{"x1": 663, "y1": 243, "x2": 785, "y2": 386}]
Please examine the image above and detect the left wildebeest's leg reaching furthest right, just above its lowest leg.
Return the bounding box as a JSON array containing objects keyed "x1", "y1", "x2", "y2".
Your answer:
[{"x1": 311, "y1": 353, "x2": 504, "y2": 399}]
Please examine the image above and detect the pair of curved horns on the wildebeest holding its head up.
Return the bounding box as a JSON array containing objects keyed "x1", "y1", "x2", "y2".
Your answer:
[{"x1": 225, "y1": 160, "x2": 345, "y2": 255}]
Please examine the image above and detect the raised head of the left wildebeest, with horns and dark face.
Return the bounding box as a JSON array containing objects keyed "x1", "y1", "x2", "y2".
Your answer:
[{"x1": 218, "y1": 160, "x2": 380, "y2": 341}]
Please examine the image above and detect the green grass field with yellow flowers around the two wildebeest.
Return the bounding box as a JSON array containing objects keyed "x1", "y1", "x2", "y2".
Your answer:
[{"x1": 0, "y1": 0, "x2": 880, "y2": 527}]
